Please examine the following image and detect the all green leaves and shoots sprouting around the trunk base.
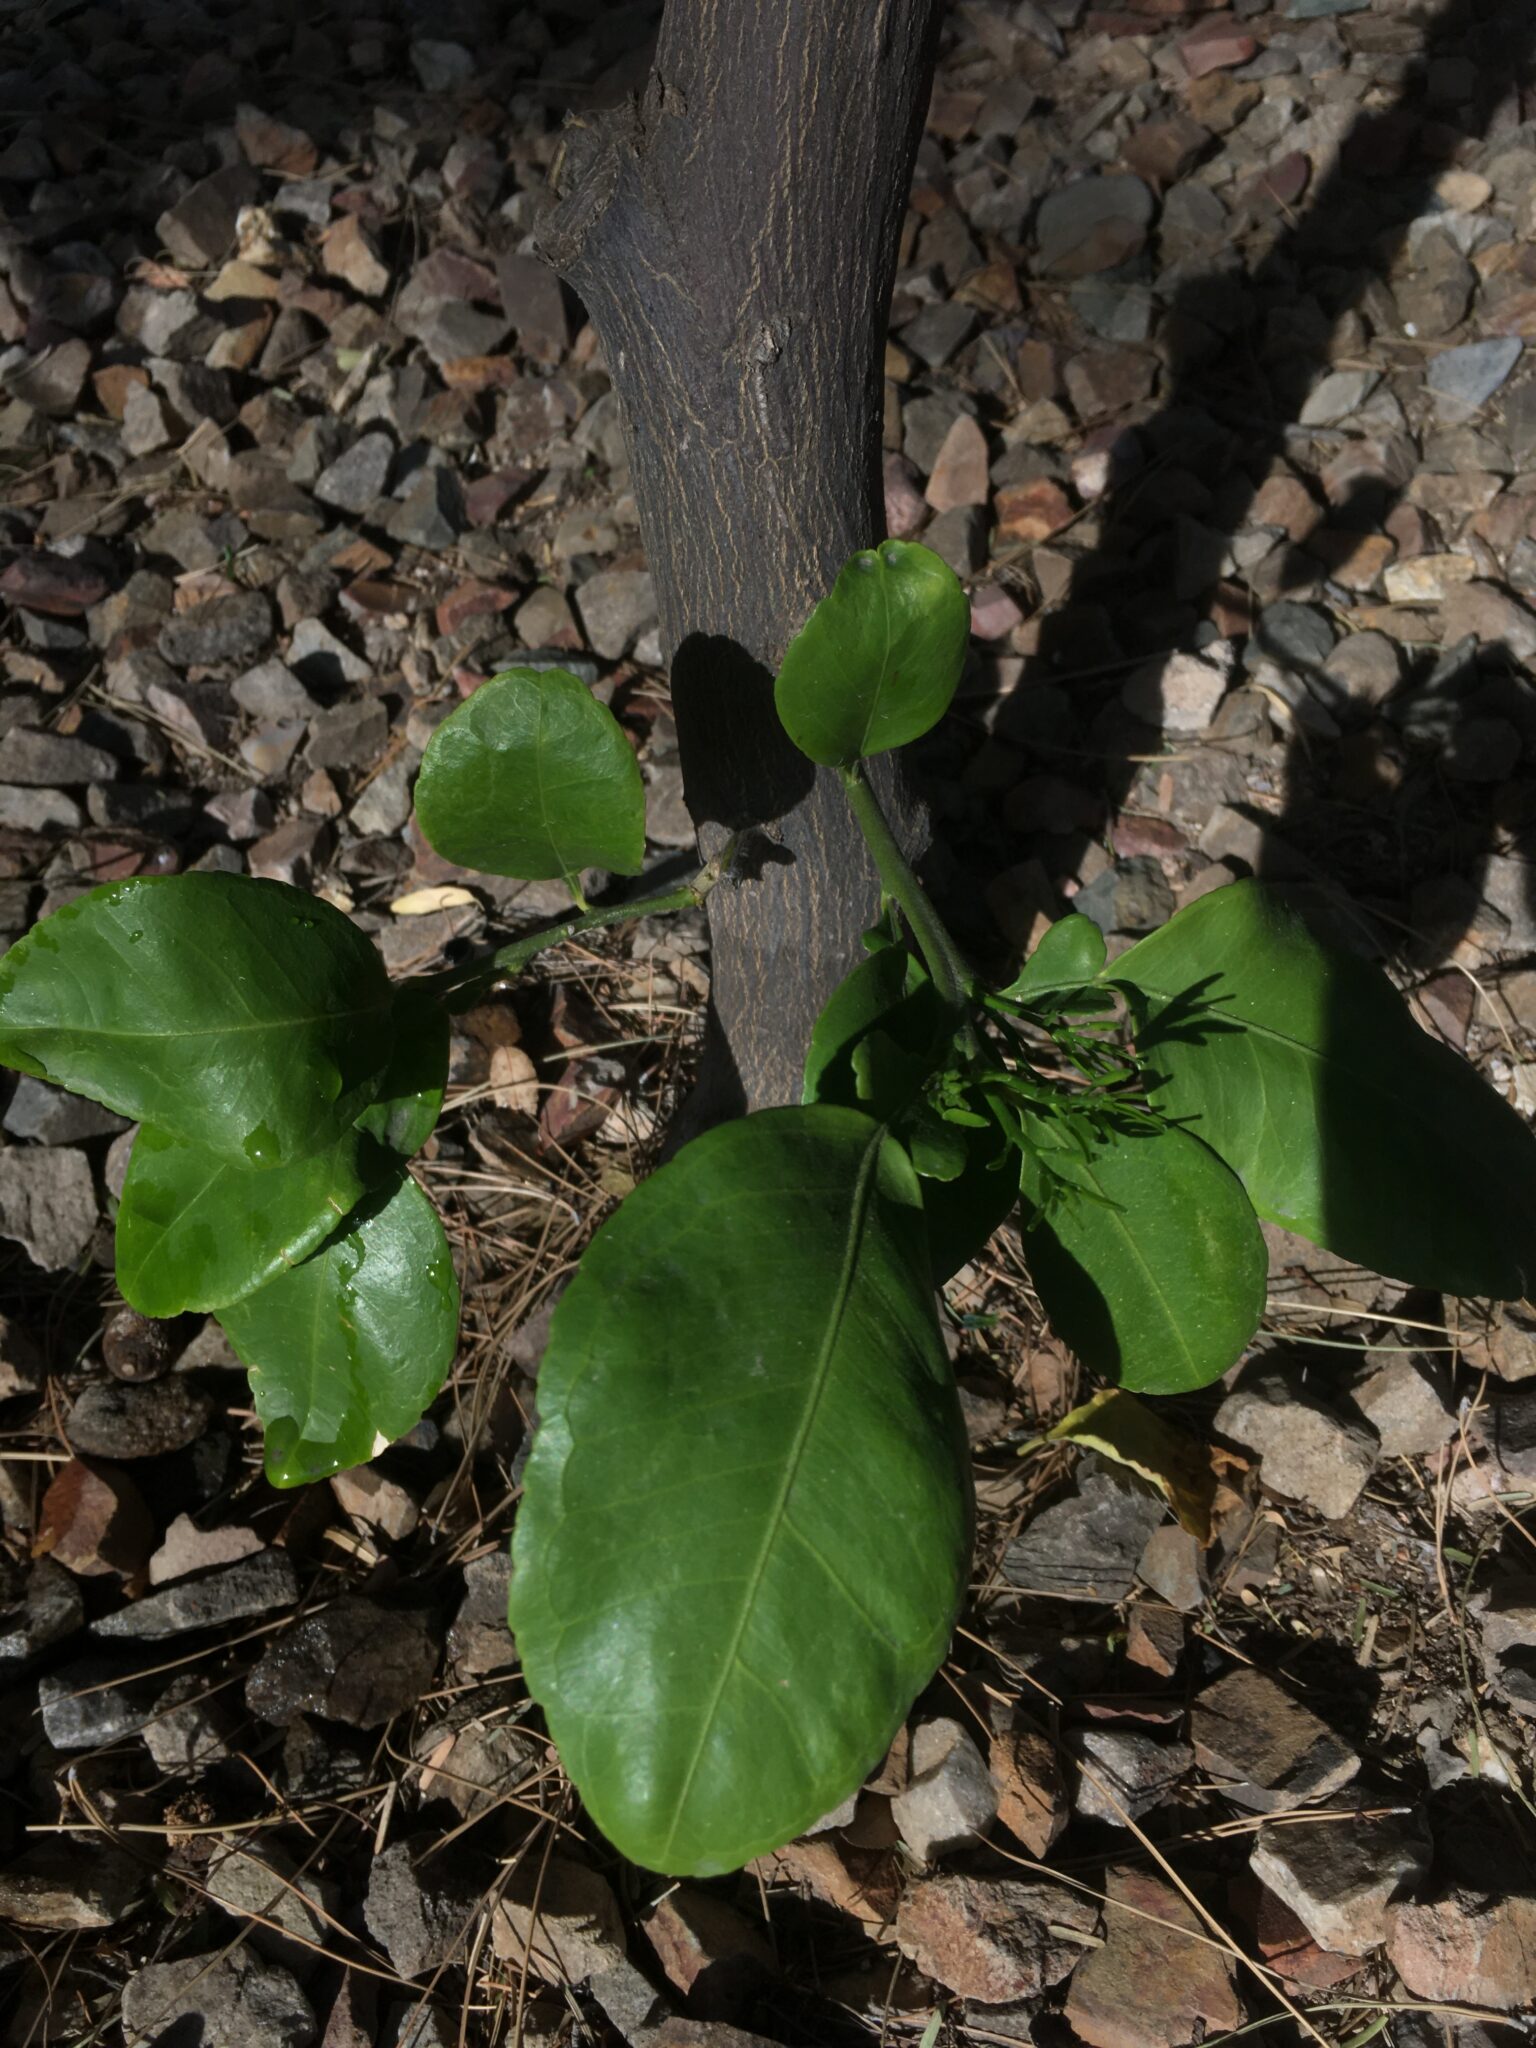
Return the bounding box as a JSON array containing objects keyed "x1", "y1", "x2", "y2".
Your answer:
[{"x1": 0, "y1": 543, "x2": 1536, "y2": 1874}]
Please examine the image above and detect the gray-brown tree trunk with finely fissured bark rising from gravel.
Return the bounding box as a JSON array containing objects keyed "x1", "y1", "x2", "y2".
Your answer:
[{"x1": 543, "y1": 0, "x2": 940, "y2": 1114}]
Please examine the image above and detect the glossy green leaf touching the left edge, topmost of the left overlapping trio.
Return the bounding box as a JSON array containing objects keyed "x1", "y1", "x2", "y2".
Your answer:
[{"x1": 0, "y1": 874, "x2": 391, "y2": 1167}]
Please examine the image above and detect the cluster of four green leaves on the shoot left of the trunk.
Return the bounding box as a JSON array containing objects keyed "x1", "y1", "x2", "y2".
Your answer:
[{"x1": 0, "y1": 670, "x2": 645, "y2": 1487}]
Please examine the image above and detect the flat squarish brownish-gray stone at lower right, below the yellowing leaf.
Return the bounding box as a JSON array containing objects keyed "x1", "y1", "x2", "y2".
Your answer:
[{"x1": 1190, "y1": 1669, "x2": 1360, "y2": 1812}]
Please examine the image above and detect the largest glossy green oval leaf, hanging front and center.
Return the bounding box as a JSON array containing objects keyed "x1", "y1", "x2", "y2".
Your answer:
[{"x1": 512, "y1": 1104, "x2": 971, "y2": 1876}]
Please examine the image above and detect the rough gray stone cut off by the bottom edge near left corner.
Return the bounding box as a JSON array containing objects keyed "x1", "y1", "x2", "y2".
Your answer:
[{"x1": 123, "y1": 1948, "x2": 319, "y2": 2048}]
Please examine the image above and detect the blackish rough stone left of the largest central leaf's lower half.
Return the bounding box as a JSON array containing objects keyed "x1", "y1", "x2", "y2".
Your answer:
[{"x1": 246, "y1": 1595, "x2": 438, "y2": 1729}]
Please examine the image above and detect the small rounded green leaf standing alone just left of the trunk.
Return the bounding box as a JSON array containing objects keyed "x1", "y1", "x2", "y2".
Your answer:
[{"x1": 416, "y1": 668, "x2": 645, "y2": 899}]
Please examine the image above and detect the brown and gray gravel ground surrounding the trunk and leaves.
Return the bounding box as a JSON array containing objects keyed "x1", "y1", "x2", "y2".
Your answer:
[{"x1": 0, "y1": 0, "x2": 1536, "y2": 2048}]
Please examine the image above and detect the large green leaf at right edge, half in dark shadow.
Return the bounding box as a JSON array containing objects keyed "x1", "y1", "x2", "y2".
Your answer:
[{"x1": 1110, "y1": 883, "x2": 1536, "y2": 1298}]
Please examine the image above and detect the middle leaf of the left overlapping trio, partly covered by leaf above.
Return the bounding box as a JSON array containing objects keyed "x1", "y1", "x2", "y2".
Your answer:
[{"x1": 117, "y1": 1124, "x2": 367, "y2": 1315}]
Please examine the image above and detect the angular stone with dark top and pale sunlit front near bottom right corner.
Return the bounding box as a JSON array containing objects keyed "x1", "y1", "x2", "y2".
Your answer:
[{"x1": 1249, "y1": 1815, "x2": 1430, "y2": 1956}]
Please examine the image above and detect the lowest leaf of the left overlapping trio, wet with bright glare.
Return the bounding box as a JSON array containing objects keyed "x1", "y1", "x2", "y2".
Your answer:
[{"x1": 219, "y1": 1174, "x2": 459, "y2": 1487}]
